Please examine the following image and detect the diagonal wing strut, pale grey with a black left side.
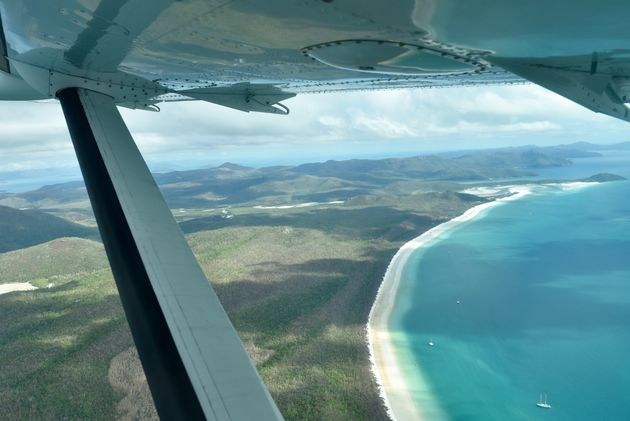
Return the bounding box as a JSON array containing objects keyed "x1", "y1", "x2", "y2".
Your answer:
[{"x1": 57, "y1": 88, "x2": 282, "y2": 420}]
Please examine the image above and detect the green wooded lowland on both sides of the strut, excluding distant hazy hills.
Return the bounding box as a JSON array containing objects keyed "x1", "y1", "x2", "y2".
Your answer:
[{"x1": 0, "y1": 194, "x2": 482, "y2": 419}]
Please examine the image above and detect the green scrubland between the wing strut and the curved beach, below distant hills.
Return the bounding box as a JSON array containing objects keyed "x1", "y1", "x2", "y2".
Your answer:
[{"x1": 189, "y1": 221, "x2": 396, "y2": 419}]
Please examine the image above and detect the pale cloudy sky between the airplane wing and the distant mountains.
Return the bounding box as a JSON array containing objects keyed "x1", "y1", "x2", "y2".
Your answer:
[{"x1": 0, "y1": 85, "x2": 630, "y2": 190}]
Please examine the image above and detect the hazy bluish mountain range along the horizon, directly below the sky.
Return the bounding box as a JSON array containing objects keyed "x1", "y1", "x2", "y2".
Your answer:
[{"x1": 0, "y1": 142, "x2": 612, "y2": 210}]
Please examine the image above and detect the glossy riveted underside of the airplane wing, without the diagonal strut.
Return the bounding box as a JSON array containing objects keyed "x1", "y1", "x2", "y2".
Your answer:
[{"x1": 0, "y1": 0, "x2": 630, "y2": 119}]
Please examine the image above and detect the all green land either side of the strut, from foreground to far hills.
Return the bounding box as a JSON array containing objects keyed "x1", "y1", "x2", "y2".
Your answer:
[{"x1": 0, "y1": 147, "x2": 616, "y2": 420}]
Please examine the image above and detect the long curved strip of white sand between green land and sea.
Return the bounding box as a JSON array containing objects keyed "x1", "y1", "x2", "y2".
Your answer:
[{"x1": 366, "y1": 183, "x2": 540, "y2": 420}]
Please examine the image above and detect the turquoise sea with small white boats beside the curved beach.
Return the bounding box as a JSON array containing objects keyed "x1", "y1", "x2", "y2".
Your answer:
[{"x1": 390, "y1": 173, "x2": 630, "y2": 420}]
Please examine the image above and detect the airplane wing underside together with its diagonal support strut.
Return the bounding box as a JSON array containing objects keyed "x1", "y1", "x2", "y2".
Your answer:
[{"x1": 0, "y1": 0, "x2": 630, "y2": 420}]
